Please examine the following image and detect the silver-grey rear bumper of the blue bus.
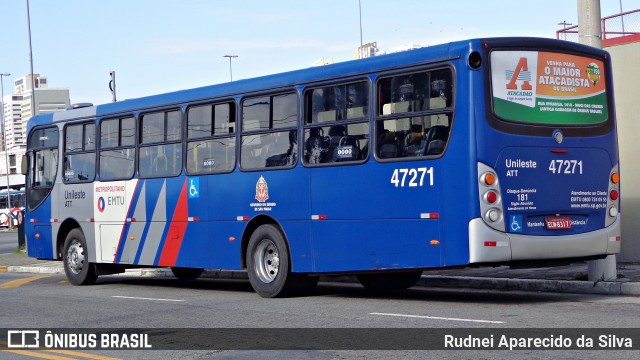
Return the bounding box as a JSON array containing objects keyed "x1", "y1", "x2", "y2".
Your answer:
[{"x1": 469, "y1": 216, "x2": 620, "y2": 264}]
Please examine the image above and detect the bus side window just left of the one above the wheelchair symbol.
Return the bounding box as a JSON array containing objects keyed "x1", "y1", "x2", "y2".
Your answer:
[{"x1": 138, "y1": 110, "x2": 182, "y2": 178}]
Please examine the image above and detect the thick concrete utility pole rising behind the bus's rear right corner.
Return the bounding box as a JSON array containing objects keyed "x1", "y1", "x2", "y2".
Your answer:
[{"x1": 578, "y1": 0, "x2": 618, "y2": 281}]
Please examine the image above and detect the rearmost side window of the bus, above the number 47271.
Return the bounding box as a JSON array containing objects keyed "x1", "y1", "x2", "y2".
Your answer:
[{"x1": 376, "y1": 68, "x2": 453, "y2": 159}]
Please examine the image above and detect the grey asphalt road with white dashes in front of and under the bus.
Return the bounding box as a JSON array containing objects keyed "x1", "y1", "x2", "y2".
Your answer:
[{"x1": 0, "y1": 273, "x2": 640, "y2": 360}]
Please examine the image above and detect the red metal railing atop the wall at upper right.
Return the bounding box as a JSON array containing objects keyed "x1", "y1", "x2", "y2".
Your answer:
[{"x1": 556, "y1": 9, "x2": 640, "y2": 45}]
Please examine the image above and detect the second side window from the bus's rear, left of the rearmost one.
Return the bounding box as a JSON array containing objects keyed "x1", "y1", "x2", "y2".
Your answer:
[{"x1": 303, "y1": 81, "x2": 369, "y2": 165}]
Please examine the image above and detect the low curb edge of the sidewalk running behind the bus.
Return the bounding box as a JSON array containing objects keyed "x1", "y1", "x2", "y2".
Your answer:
[{"x1": 5, "y1": 261, "x2": 640, "y2": 296}]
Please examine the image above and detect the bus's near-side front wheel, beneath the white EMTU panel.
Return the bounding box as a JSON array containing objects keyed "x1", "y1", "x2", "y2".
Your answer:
[{"x1": 62, "y1": 228, "x2": 98, "y2": 285}]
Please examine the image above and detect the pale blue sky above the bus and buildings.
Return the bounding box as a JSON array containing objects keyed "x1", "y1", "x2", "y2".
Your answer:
[{"x1": 0, "y1": 0, "x2": 640, "y2": 105}]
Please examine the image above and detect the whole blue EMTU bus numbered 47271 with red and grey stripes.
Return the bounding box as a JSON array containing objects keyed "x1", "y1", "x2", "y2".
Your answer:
[{"x1": 23, "y1": 38, "x2": 621, "y2": 297}]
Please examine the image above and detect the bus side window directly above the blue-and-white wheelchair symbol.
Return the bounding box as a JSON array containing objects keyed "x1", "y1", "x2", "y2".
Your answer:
[{"x1": 187, "y1": 102, "x2": 236, "y2": 174}]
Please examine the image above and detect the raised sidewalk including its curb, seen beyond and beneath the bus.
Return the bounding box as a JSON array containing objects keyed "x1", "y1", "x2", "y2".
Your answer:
[{"x1": 0, "y1": 253, "x2": 640, "y2": 296}]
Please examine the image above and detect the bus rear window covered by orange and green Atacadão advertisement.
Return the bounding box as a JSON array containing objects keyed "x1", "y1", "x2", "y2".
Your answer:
[{"x1": 491, "y1": 51, "x2": 609, "y2": 126}]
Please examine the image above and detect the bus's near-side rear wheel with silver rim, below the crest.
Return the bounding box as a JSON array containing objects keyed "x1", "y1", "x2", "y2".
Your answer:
[{"x1": 246, "y1": 224, "x2": 302, "y2": 298}]
